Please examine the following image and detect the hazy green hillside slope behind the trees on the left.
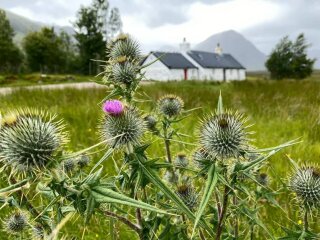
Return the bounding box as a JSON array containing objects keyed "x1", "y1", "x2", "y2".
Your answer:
[{"x1": 1, "y1": 9, "x2": 74, "y2": 44}]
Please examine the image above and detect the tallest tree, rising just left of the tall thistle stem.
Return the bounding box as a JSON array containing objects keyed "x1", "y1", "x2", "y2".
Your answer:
[{"x1": 74, "y1": 0, "x2": 122, "y2": 74}]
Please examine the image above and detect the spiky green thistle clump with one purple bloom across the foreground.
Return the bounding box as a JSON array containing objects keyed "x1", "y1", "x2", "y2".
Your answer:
[{"x1": 0, "y1": 34, "x2": 308, "y2": 240}]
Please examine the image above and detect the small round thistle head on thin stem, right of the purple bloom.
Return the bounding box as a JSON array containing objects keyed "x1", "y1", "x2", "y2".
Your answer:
[{"x1": 158, "y1": 94, "x2": 184, "y2": 117}]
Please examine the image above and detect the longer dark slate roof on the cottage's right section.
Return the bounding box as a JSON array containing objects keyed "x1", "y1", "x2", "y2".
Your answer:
[{"x1": 188, "y1": 51, "x2": 244, "y2": 69}]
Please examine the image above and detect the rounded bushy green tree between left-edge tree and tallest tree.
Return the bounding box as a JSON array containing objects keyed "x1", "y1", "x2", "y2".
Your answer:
[{"x1": 23, "y1": 27, "x2": 66, "y2": 73}]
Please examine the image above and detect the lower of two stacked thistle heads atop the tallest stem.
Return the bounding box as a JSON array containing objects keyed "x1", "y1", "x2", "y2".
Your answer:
[{"x1": 112, "y1": 62, "x2": 138, "y2": 84}]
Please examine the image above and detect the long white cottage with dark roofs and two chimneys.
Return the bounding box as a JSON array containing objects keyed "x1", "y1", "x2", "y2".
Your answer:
[{"x1": 142, "y1": 39, "x2": 246, "y2": 81}]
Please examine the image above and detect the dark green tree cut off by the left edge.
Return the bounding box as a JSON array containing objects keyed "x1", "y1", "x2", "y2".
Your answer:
[{"x1": 0, "y1": 10, "x2": 23, "y2": 72}]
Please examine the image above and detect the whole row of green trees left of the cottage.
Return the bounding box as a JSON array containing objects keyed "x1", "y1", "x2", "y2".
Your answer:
[{"x1": 0, "y1": 0, "x2": 122, "y2": 74}]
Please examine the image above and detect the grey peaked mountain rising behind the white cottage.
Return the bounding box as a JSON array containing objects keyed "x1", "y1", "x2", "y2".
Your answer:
[{"x1": 194, "y1": 30, "x2": 267, "y2": 71}]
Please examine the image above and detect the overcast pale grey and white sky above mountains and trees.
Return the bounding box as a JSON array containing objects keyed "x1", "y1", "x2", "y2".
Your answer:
[{"x1": 0, "y1": 0, "x2": 320, "y2": 54}]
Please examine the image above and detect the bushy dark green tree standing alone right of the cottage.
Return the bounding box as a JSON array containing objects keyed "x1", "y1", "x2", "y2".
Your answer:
[{"x1": 266, "y1": 34, "x2": 315, "y2": 79}]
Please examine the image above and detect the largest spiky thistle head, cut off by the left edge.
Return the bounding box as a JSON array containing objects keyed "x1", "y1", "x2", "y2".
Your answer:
[{"x1": 0, "y1": 110, "x2": 66, "y2": 172}]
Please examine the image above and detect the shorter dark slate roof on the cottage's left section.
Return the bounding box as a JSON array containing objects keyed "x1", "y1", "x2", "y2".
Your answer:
[{"x1": 151, "y1": 52, "x2": 197, "y2": 69}]
